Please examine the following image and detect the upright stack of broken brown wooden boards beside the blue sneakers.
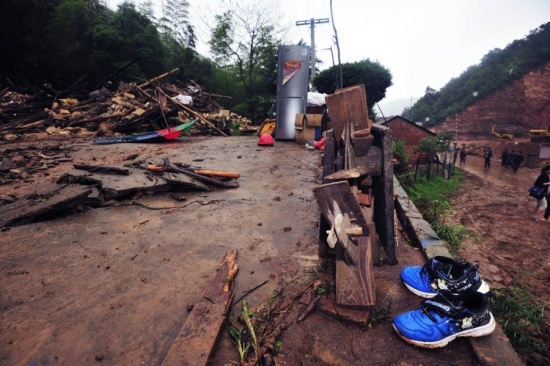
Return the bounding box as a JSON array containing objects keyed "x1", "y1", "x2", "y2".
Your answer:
[{"x1": 314, "y1": 85, "x2": 396, "y2": 324}]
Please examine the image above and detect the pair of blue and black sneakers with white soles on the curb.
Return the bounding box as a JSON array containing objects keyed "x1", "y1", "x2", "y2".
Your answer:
[{"x1": 393, "y1": 256, "x2": 495, "y2": 348}]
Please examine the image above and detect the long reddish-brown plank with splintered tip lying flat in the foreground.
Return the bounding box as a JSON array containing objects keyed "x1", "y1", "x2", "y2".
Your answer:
[{"x1": 162, "y1": 250, "x2": 238, "y2": 366}]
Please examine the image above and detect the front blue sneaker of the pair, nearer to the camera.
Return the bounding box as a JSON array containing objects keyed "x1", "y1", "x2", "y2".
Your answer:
[{"x1": 393, "y1": 292, "x2": 496, "y2": 348}]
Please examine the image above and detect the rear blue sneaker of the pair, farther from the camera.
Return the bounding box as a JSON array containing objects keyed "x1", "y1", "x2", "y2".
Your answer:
[{"x1": 401, "y1": 256, "x2": 490, "y2": 298}]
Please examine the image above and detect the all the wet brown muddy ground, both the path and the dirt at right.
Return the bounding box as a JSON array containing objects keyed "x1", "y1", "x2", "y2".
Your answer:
[{"x1": 0, "y1": 137, "x2": 550, "y2": 365}]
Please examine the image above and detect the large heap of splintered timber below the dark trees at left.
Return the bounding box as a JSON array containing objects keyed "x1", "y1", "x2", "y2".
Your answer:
[{"x1": 0, "y1": 69, "x2": 257, "y2": 141}]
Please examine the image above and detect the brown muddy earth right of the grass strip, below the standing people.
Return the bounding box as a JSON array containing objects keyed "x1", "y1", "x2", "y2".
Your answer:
[{"x1": 448, "y1": 151, "x2": 550, "y2": 365}]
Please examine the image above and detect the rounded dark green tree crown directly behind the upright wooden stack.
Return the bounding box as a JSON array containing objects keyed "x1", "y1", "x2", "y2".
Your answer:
[{"x1": 313, "y1": 59, "x2": 392, "y2": 118}]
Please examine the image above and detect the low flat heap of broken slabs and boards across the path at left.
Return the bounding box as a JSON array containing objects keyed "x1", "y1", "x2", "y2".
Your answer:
[{"x1": 0, "y1": 157, "x2": 240, "y2": 231}]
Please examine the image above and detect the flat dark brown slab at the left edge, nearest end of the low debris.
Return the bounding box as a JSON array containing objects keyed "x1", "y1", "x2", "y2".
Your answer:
[{"x1": 0, "y1": 184, "x2": 92, "y2": 227}]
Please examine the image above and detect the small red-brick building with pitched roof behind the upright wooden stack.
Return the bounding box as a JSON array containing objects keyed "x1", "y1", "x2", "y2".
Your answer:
[{"x1": 376, "y1": 116, "x2": 437, "y2": 162}]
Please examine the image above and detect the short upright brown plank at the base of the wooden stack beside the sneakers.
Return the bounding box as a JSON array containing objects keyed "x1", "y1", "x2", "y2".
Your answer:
[{"x1": 335, "y1": 235, "x2": 375, "y2": 307}]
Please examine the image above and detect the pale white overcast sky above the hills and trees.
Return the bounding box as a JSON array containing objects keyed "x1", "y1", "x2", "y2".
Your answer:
[{"x1": 107, "y1": 0, "x2": 550, "y2": 102}]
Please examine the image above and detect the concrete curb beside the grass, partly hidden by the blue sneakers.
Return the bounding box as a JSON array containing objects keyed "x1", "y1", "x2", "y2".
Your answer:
[{"x1": 393, "y1": 176, "x2": 524, "y2": 366}]
